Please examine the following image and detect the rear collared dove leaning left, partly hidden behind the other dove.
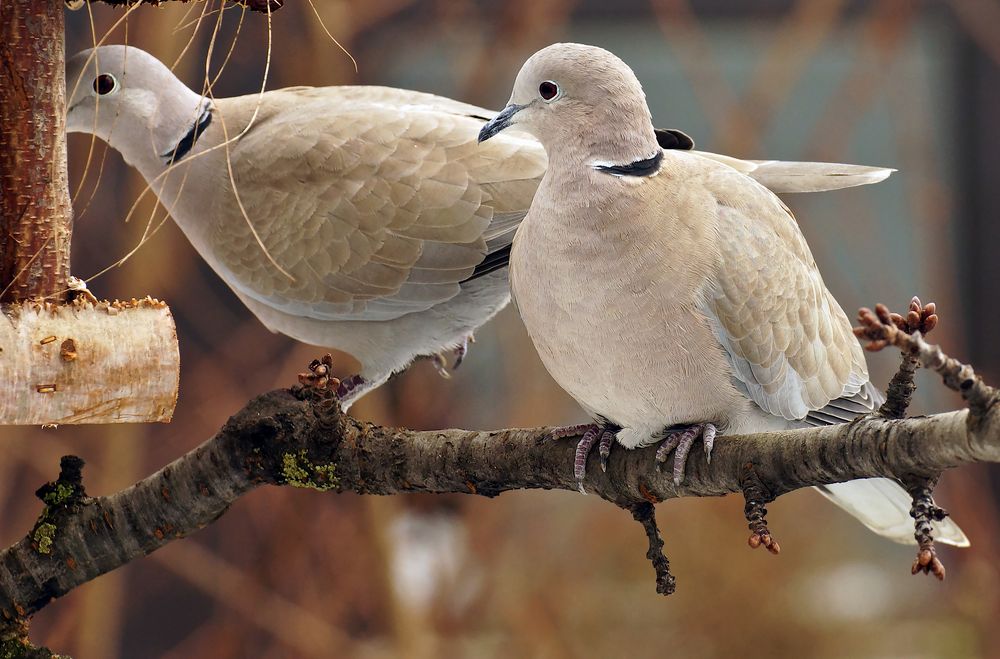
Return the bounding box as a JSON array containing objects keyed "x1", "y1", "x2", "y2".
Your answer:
[{"x1": 67, "y1": 46, "x2": 891, "y2": 409}]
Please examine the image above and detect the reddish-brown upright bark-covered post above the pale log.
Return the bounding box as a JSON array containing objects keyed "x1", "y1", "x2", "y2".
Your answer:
[{"x1": 0, "y1": 0, "x2": 73, "y2": 302}]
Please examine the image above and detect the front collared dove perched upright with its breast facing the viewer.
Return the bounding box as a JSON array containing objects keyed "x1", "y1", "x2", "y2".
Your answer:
[{"x1": 479, "y1": 44, "x2": 968, "y2": 545}]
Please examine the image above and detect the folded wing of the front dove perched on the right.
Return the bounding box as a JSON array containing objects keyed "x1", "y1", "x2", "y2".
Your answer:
[{"x1": 705, "y1": 168, "x2": 874, "y2": 423}]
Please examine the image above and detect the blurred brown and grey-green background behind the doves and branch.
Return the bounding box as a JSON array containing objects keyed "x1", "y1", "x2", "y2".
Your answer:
[{"x1": 0, "y1": 0, "x2": 1000, "y2": 659}]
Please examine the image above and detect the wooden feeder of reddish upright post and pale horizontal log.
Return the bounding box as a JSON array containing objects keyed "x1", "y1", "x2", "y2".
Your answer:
[{"x1": 0, "y1": 0, "x2": 180, "y2": 425}]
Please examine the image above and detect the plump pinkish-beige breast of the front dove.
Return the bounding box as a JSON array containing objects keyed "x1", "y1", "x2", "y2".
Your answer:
[{"x1": 511, "y1": 173, "x2": 750, "y2": 445}]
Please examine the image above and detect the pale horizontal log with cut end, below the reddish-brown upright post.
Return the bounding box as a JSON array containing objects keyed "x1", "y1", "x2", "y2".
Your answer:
[{"x1": 0, "y1": 298, "x2": 180, "y2": 426}]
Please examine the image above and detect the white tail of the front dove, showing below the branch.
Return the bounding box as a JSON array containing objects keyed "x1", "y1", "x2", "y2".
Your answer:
[{"x1": 816, "y1": 478, "x2": 969, "y2": 547}]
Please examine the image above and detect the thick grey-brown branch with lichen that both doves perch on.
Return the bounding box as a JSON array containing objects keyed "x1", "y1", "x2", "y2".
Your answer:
[{"x1": 0, "y1": 382, "x2": 1000, "y2": 619}]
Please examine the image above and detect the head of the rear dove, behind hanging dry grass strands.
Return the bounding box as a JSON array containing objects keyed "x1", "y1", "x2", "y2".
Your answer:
[{"x1": 66, "y1": 46, "x2": 208, "y2": 167}]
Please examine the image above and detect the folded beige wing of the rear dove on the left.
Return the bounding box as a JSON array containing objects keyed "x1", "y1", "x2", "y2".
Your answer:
[{"x1": 206, "y1": 87, "x2": 545, "y2": 320}]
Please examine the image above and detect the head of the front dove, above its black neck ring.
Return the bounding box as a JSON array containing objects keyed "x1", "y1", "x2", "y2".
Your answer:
[{"x1": 479, "y1": 43, "x2": 659, "y2": 163}]
